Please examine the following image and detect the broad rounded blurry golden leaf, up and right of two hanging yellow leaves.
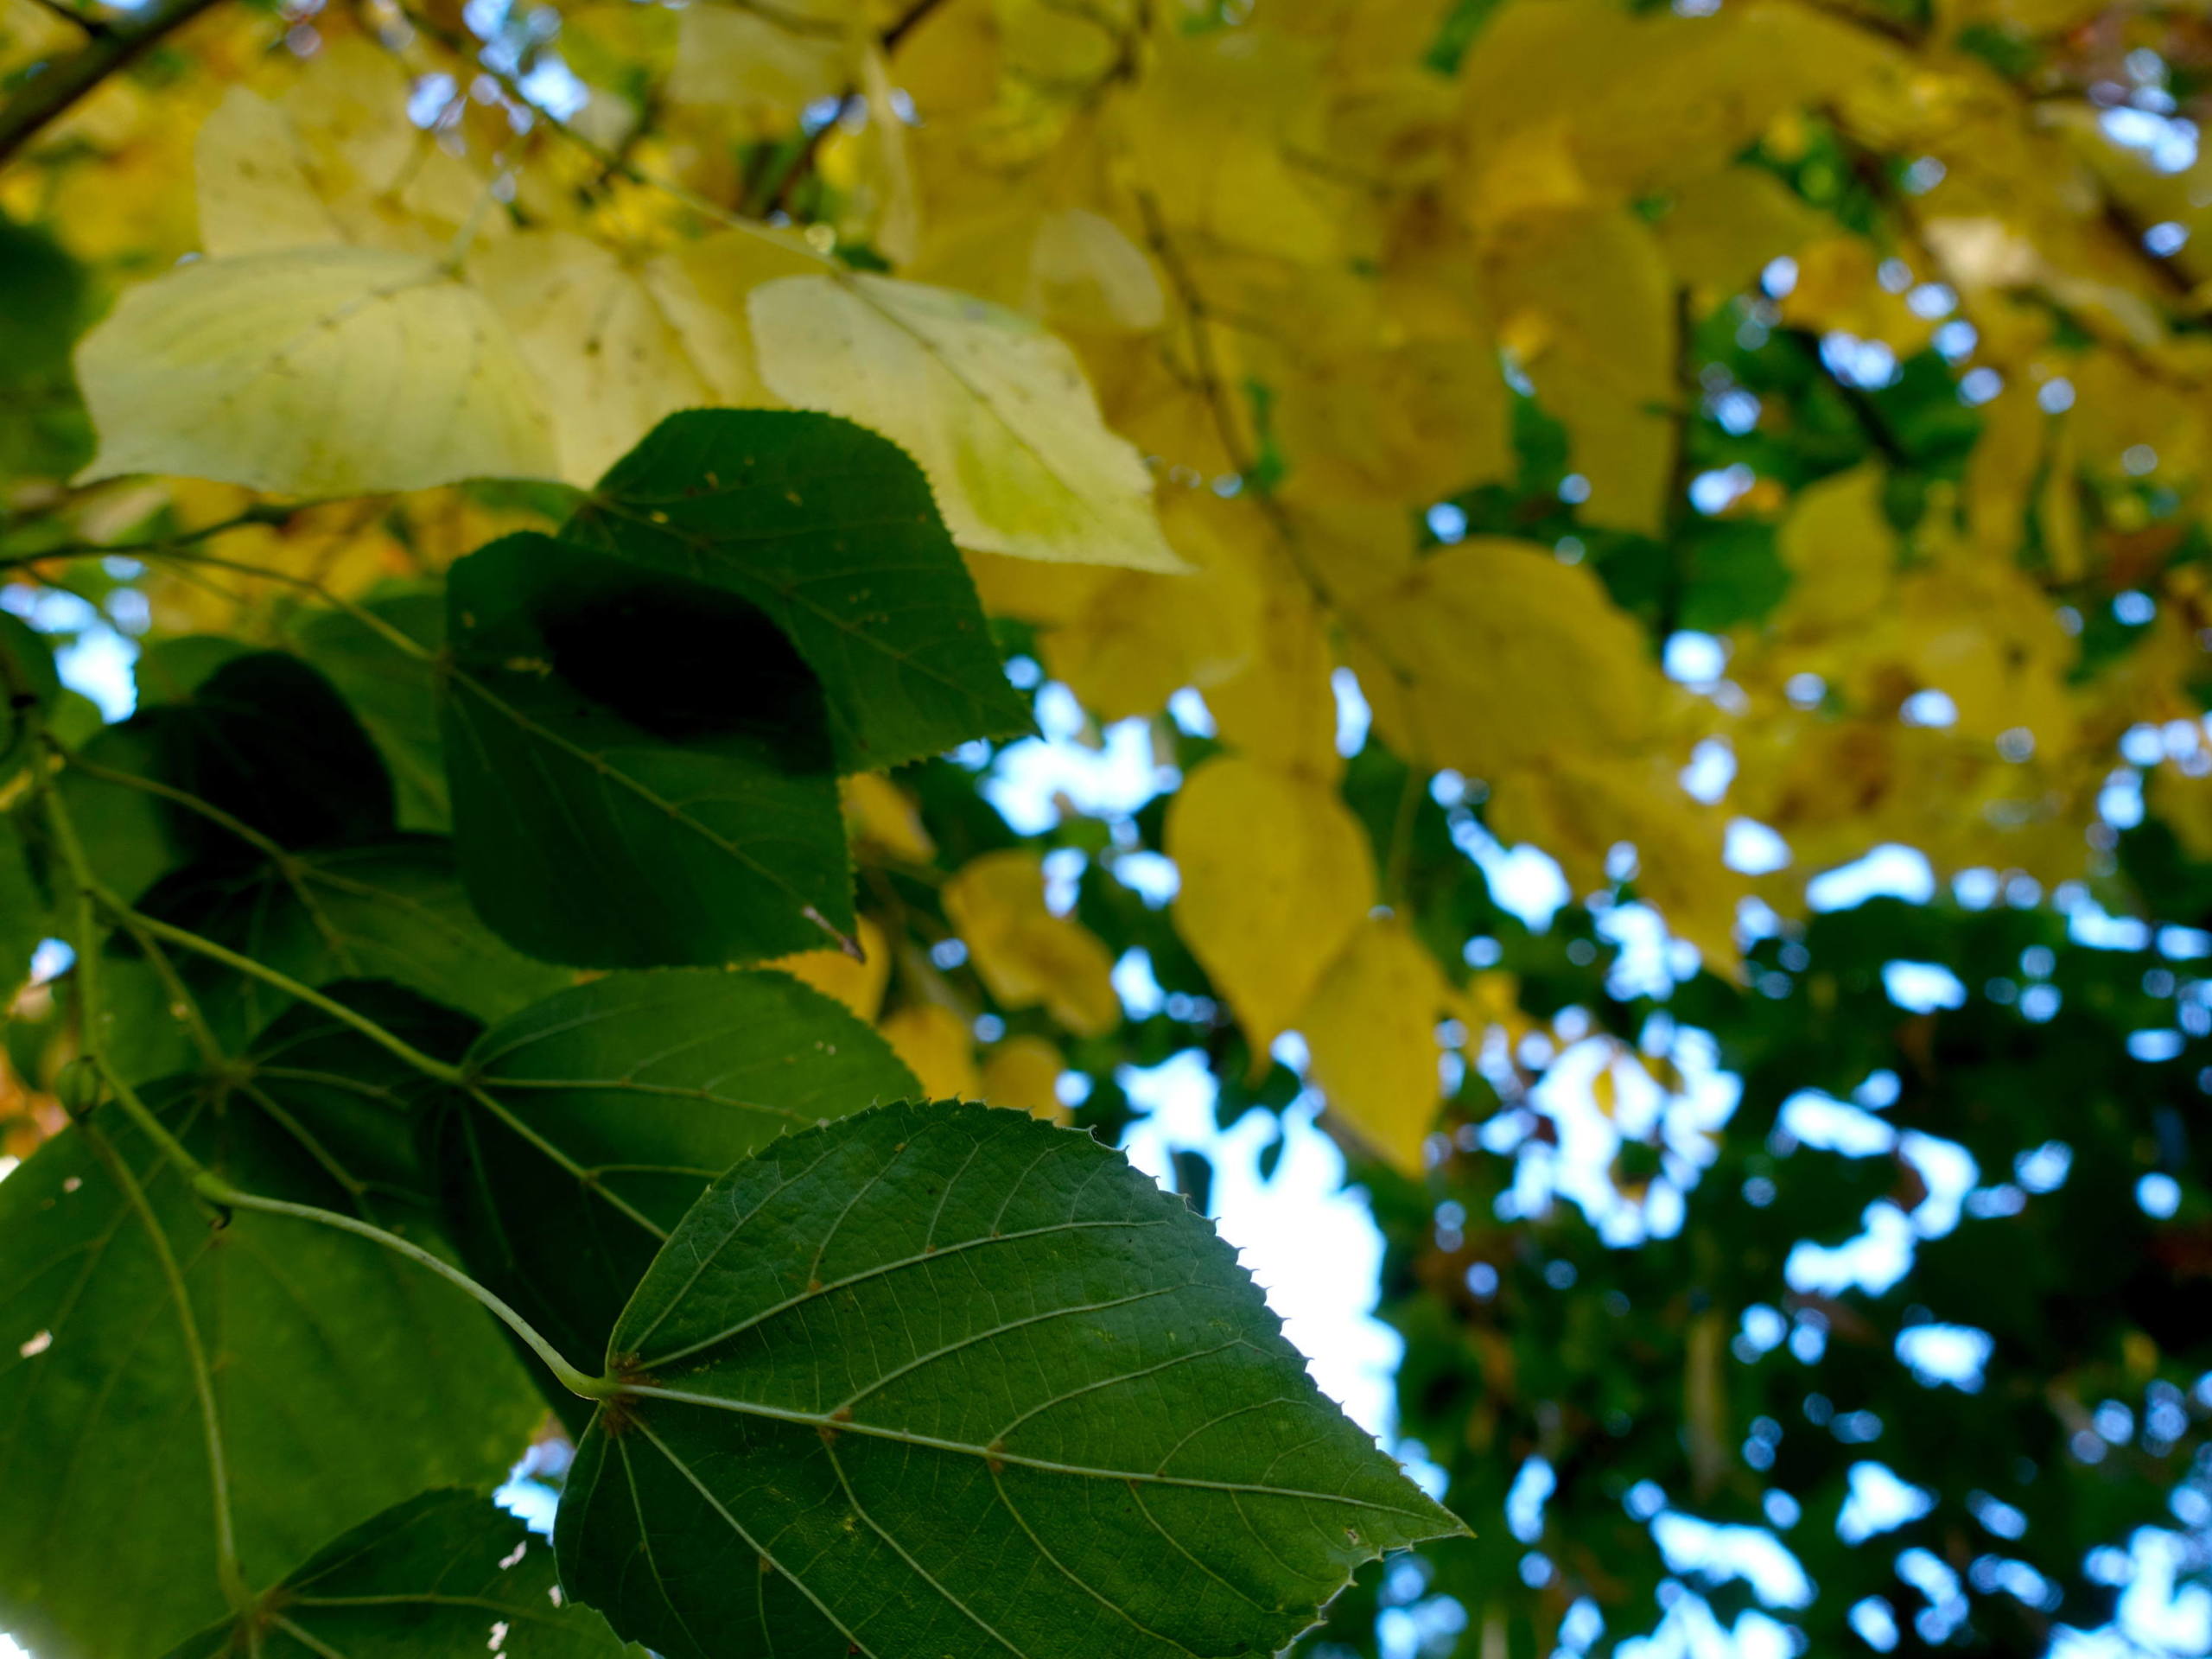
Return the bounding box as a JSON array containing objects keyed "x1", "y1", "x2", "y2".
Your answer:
[{"x1": 1344, "y1": 536, "x2": 1666, "y2": 779}]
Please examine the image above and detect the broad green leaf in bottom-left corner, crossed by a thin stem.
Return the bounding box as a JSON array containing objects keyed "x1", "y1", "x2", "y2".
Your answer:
[{"x1": 0, "y1": 1079, "x2": 542, "y2": 1659}]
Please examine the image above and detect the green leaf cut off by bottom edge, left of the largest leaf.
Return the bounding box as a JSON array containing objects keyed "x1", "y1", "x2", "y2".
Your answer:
[{"x1": 168, "y1": 1491, "x2": 635, "y2": 1659}]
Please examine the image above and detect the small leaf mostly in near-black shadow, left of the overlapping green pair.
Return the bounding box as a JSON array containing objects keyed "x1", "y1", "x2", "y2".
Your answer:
[{"x1": 62, "y1": 641, "x2": 391, "y2": 900}]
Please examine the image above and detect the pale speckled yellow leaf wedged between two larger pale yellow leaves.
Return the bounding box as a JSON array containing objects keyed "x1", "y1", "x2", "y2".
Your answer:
[{"x1": 469, "y1": 230, "x2": 721, "y2": 486}]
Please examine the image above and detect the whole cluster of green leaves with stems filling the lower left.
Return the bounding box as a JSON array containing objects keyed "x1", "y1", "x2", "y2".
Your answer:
[{"x1": 0, "y1": 411, "x2": 1458, "y2": 1659}]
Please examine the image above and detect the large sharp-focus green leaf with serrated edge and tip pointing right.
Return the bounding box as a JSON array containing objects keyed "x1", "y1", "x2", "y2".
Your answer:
[{"x1": 556, "y1": 1106, "x2": 1465, "y2": 1659}]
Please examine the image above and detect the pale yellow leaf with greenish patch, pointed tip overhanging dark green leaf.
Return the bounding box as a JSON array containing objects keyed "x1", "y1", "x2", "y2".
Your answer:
[{"x1": 747, "y1": 276, "x2": 1184, "y2": 570}]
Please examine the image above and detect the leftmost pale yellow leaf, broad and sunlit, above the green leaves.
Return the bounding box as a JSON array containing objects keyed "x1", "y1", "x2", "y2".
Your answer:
[{"x1": 78, "y1": 248, "x2": 557, "y2": 495}]
